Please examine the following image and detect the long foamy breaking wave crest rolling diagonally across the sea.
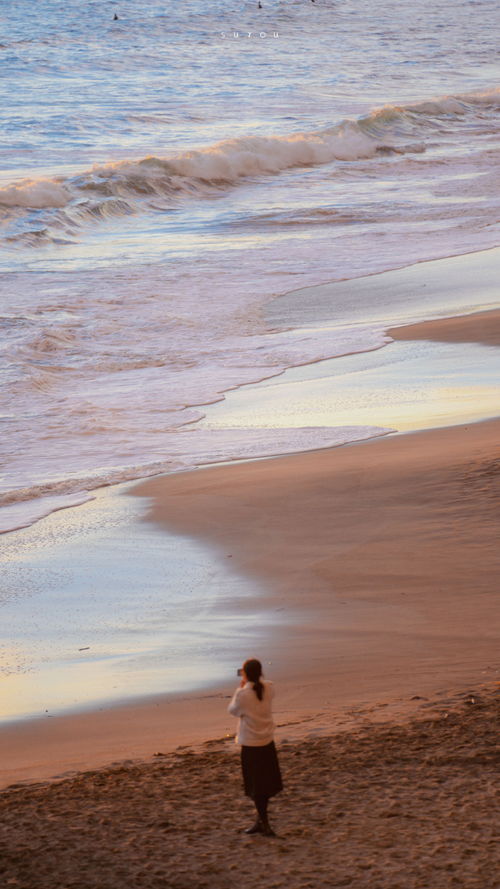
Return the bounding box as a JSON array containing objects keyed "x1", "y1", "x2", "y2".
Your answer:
[{"x1": 0, "y1": 89, "x2": 500, "y2": 246}]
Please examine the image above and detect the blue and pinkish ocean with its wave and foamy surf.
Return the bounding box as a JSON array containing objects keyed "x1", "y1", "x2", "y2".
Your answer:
[{"x1": 0, "y1": 0, "x2": 500, "y2": 720}]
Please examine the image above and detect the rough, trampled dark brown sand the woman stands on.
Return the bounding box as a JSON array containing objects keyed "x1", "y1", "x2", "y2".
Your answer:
[{"x1": 0, "y1": 692, "x2": 500, "y2": 889}]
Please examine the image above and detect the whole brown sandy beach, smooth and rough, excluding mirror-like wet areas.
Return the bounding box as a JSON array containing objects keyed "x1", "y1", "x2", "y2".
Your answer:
[{"x1": 0, "y1": 302, "x2": 500, "y2": 889}]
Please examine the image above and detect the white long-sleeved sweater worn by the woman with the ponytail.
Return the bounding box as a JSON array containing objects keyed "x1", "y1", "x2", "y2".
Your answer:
[{"x1": 227, "y1": 679, "x2": 274, "y2": 747}]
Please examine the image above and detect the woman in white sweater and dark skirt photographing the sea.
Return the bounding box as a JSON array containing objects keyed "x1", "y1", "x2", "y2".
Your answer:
[{"x1": 228, "y1": 658, "x2": 283, "y2": 837}]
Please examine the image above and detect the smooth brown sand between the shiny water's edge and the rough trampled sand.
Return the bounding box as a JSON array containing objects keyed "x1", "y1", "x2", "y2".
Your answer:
[{"x1": 0, "y1": 412, "x2": 500, "y2": 786}]
